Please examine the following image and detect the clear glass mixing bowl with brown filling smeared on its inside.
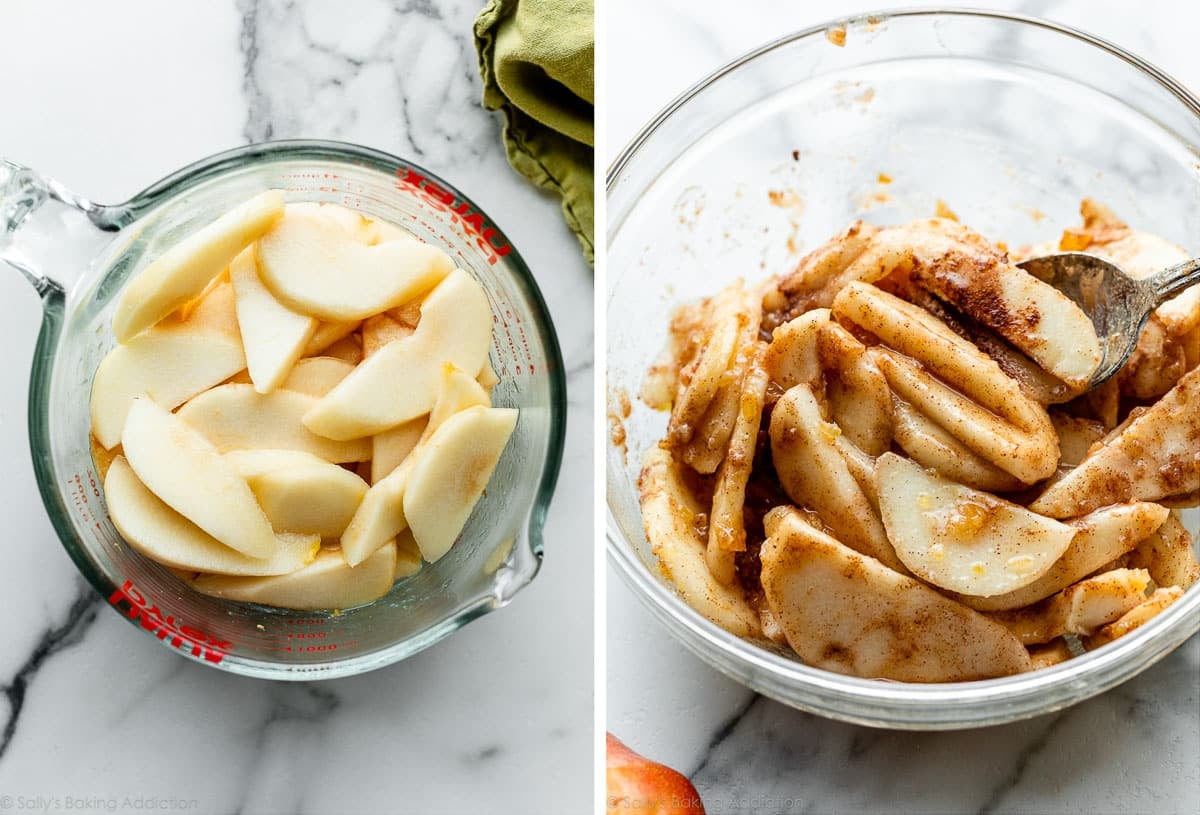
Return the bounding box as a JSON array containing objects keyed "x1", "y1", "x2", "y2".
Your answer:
[{"x1": 606, "y1": 11, "x2": 1200, "y2": 730}]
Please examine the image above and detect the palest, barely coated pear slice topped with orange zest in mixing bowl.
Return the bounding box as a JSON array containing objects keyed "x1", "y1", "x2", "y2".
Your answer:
[{"x1": 875, "y1": 453, "x2": 1075, "y2": 597}]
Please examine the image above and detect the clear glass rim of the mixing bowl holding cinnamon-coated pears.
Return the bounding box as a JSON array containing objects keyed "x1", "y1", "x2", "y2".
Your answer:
[{"x1": 605, "y1": 6, "x2": 1200, "y2": 730}]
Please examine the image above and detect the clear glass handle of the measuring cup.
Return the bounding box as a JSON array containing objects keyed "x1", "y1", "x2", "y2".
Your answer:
[{"x1": 0, "y1": 158, "x2": 125, "y2": 299}]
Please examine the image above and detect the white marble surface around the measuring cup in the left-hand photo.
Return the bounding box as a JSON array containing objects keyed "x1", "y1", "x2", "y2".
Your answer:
[{"x1": 0, "y1": 0, "x2": 593, "y2": 814}]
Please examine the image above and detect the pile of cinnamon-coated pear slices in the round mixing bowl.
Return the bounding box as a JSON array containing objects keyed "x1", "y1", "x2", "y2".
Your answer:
[{"x1": 638, "y1": 200, "x2": 1200, "y2": 682}]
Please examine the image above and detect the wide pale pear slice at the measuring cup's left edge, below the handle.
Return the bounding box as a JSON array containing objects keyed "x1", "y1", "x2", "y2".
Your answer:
[{"x1": 91, "y1": 323, "x2": 246, "y2": 449}]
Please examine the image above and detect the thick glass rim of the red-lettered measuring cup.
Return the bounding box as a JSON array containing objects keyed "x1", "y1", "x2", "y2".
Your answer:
[{"x1": 26, "y1": 139, "x2": 566, "y2": 682}]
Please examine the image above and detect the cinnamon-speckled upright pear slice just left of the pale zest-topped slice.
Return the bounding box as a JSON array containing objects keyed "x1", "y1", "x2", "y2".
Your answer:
[{"x1": 769, "y1": 384, "x2": 905, "y2": 571}]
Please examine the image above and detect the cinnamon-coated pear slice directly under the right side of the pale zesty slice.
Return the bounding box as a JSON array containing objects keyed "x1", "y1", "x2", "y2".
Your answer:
[{"x1": 952, "y1": 503, "x2": 1168, "y2": 611}]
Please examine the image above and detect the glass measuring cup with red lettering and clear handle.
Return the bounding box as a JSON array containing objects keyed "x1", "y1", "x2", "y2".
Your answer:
[{"x1": 0, "y1": 142, "x2": 566, "y2": 679}]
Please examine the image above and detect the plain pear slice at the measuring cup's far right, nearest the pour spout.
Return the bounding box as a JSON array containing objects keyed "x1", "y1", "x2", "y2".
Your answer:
[{"x1": 404, "y1": 406, "x2": 517, "y2": 563}]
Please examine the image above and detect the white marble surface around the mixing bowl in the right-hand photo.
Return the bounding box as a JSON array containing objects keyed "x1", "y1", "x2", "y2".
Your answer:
[{"x1": 605, "y1": 0, "x2": 1200, "y2": 815}]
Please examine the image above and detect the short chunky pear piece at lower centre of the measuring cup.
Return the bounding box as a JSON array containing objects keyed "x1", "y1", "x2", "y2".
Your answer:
[{"x1": 226, "y1": 450, "x2": 367, "y2": 538}]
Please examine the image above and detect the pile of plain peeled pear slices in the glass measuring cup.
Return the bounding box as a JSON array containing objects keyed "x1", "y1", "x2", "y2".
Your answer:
[{"x1": 84, "y1": 191, "x2": 517, "y2": 610}]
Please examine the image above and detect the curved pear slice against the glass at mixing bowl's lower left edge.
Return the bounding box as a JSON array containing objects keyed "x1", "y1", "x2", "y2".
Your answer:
[{"x1": 637, "y1": 447, "x2": 761, "y2": 636}]
